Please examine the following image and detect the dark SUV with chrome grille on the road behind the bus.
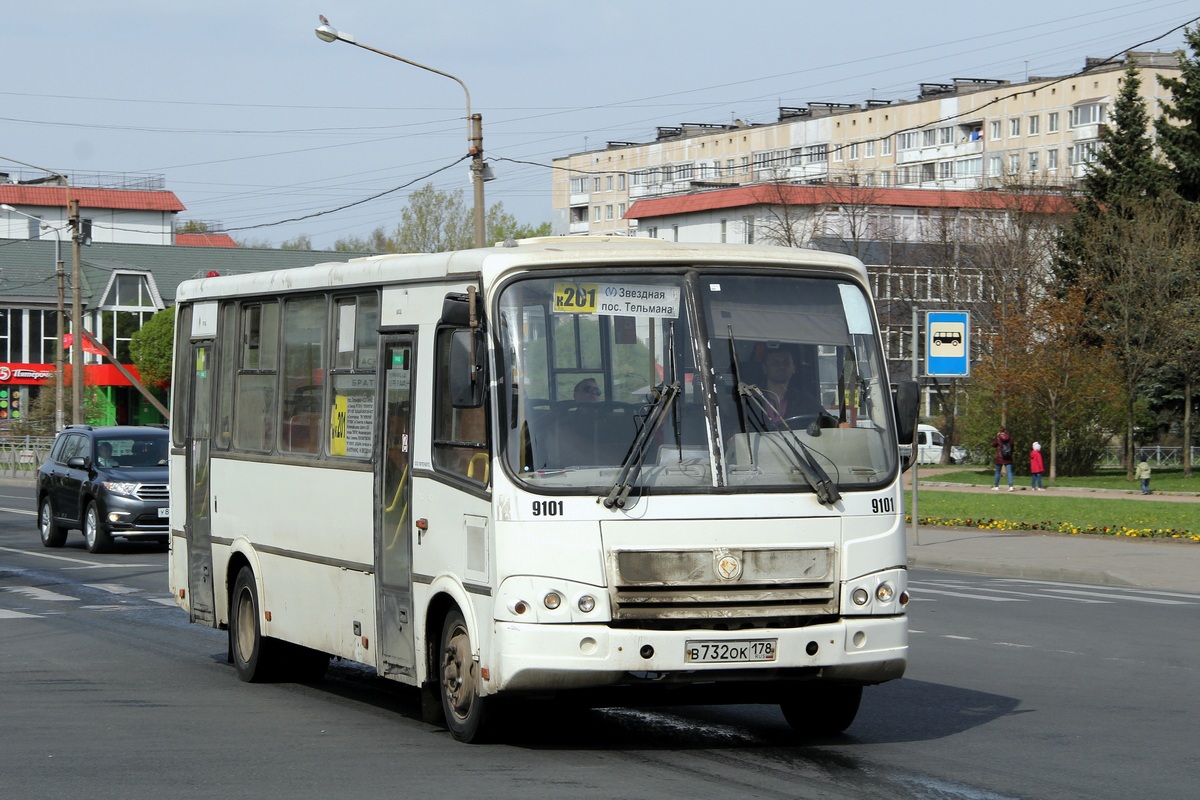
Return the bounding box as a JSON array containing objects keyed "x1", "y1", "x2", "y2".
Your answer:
[{"x1": 37, "y1": 425, "x2": 170, "y2": 553}]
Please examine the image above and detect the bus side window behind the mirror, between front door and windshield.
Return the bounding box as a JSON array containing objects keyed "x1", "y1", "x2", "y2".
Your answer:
[{"x1": 433, "y1": 327, "x2": 491, "y2": 486}]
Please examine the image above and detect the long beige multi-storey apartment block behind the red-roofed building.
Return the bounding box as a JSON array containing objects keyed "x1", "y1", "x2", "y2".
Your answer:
[{"x1": 552, "y1": 52, "x2": 1180, "y2": 241}]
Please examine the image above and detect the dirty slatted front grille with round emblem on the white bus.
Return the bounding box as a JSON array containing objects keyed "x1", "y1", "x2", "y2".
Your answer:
[{"x1": 608, "y1": 548, "x2": 838, "y2": 620}]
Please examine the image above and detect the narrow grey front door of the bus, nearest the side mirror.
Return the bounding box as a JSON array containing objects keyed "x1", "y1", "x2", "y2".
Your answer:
[{"x1": 376, "y1": 335, "x2": 415, "y2": 675}]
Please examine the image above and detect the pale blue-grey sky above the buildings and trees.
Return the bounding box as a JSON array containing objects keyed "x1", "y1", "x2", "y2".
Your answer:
[{"x1": 0, "y1": 0, "x2": 1200, "y2": 248}]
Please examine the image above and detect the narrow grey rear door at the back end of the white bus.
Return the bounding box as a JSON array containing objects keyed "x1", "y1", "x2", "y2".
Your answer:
[{"x1": 182, "y1": 342, "x2": 216, "y2": 625}]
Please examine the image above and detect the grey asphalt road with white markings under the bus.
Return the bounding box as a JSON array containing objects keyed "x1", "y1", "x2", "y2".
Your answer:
[{"x1": 0, "y1": 486, "x2": 1200, "y2": 800}]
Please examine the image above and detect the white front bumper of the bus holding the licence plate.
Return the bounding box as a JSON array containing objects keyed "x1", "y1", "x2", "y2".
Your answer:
[{"x1": 485, "y1": 615, "x2": 908, "y2": 693}]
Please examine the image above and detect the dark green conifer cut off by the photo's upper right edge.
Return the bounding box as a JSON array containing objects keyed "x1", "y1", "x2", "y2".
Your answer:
[{"x1": 1154, "y1": 28, "x2": 1200, "y2": 203}]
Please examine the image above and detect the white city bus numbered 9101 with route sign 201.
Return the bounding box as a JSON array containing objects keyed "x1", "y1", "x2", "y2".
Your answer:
[{"x1": 170, "y1": 237, "x2": 917, "y2": 741}]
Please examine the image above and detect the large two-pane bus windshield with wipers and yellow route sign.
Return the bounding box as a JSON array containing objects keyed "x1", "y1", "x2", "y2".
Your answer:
[{"x1": 498, "y1": 267, "x2": 898, "y2": 501}]
